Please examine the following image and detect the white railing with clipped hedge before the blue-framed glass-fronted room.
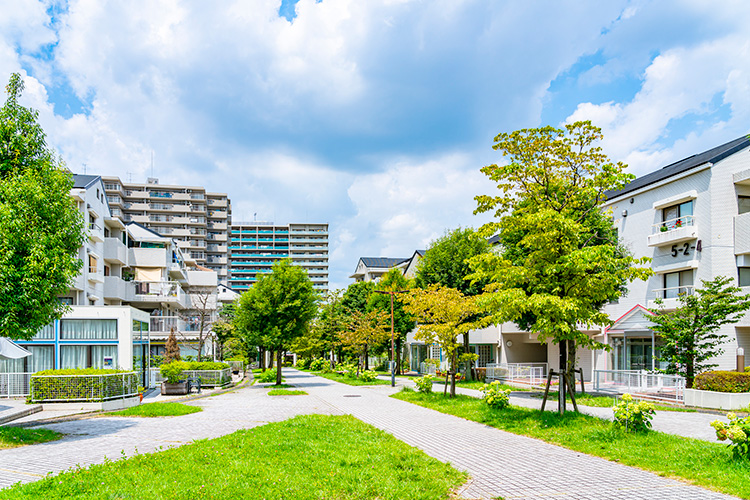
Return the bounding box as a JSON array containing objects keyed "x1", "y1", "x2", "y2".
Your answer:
[{"x1": 30, "y1": 372, "x2": 139, "y2": 403}]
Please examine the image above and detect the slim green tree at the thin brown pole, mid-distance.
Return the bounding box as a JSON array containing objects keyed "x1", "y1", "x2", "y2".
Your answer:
[{"x1": 367, "y1": 268, "x2": 416, "y2": 373}]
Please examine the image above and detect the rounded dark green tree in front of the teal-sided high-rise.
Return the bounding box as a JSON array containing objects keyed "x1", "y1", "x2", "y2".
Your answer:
[{"x1": 236, "y1": 259, "x2": 318, "y2": 385}]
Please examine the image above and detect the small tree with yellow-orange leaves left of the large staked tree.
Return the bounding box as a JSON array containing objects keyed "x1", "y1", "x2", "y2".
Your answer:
[{"x1": 404, "y1": 285, "x2": 489, "y2": 397}]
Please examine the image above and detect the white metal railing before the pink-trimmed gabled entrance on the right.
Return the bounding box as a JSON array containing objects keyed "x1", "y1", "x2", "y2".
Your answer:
[{"x1": 594, "y1": 370, "x2": 685, "y2": 403}]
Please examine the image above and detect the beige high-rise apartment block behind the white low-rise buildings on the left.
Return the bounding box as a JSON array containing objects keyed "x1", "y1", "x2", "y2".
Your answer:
[{"x1": 102, "y1": 177, "x2": 232, "y2": 283}]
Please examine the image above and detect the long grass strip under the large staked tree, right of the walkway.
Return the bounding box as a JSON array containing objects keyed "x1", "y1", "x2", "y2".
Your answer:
[{"x1": 392, "y1": 391, "x2": 750, "y2": 498}]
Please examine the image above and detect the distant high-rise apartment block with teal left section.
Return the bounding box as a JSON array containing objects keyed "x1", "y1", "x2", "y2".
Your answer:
[{"x1": 229, "y1": 222, "x2": 328, "y2": 292}]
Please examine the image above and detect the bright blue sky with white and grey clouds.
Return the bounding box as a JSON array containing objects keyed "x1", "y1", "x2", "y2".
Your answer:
[{"x1": 0, "y1": 0, "x2": 750, "y2": 288}]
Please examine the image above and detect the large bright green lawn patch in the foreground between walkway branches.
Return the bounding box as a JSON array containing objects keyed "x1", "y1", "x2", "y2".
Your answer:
[{"x1": 0, "y1": 415, "x2": 466, "y2": 500}]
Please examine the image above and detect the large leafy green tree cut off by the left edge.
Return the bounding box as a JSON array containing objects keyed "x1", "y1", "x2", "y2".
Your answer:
[{"x1": 0, "y1": 74, "x2": 84, "y2": 340}]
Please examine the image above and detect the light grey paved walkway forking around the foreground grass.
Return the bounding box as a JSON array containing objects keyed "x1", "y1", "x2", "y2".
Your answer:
[{"x1": 0, "y1": 370, "x2": 731, "y2": 500}]
